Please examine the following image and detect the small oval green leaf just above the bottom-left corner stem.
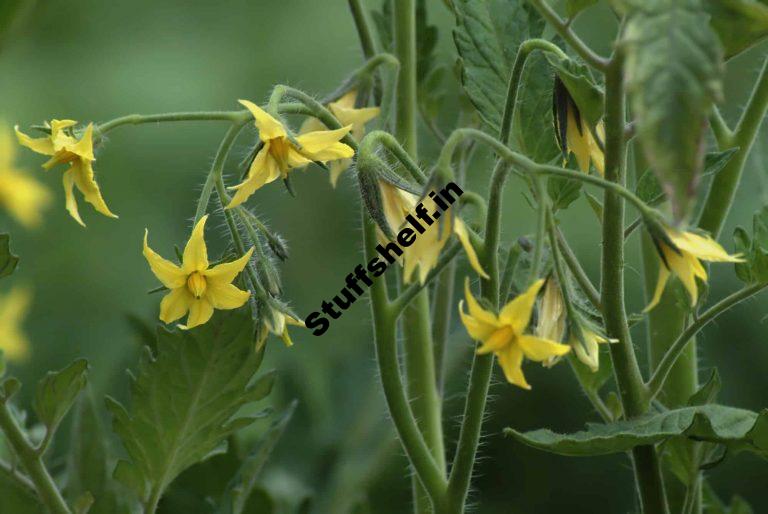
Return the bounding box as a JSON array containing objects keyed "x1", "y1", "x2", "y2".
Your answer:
[{"x1": 33, "y1": 359, "x2": 88, "y2": 434}]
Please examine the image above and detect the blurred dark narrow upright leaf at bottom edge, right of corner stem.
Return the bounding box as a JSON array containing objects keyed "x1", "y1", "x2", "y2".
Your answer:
[{"x1": 64, "y1": 391, "x2": 125, "y2": 514}]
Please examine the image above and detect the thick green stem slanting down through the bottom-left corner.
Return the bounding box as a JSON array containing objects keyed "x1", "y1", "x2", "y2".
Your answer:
[{"x1": 0, "y1": 402, "x2": 72, "y2": 514}]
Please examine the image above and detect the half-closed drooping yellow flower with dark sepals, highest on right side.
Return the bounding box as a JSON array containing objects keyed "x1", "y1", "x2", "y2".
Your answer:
[{"x1": 552, "y1": 77, "x2": 605, "y2": 176}]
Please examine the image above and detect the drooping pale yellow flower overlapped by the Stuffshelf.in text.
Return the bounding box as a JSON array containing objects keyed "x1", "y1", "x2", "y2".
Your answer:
[{"x1": 378, "y1": 180, "x2": 488, "y2": 284}]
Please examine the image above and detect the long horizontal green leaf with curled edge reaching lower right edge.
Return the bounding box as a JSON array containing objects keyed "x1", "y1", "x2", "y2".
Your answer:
[{"x1": 505, "y1": 405, "x2": 768, "y2": 458}]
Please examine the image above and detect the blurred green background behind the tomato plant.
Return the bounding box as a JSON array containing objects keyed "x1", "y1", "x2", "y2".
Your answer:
[{"x1": 0, "y1": 0, "x2": 768, "y2": 514}]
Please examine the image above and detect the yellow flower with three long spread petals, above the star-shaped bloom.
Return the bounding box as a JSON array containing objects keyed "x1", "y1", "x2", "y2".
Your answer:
[{"x1": 227, "y1": 100, "x2": 355, "y2": 209}]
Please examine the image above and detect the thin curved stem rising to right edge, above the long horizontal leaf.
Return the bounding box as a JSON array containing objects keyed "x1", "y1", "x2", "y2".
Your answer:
[{"x1": 648, "y1": 283, "x2": 768, "y2": 400}]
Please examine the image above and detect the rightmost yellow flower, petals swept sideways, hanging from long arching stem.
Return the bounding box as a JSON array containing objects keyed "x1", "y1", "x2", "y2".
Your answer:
[{"x1": 645, "y1": 228, "x2": 743, "y2": 312}]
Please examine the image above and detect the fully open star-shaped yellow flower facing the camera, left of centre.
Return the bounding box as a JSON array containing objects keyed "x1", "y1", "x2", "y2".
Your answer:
[{"x1": 144, "y1": 216, "x2": 253, "y2": 329}]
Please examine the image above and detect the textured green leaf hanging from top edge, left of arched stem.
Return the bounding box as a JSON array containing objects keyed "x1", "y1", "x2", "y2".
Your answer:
[{"x1": 453, "y1": 0, "x2": 551, "y2": 136}]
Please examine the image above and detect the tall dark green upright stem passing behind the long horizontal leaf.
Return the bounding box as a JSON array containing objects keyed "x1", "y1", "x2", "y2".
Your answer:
[{"x1": 601, "y1": 53, "x2": 669, "y2": 514}]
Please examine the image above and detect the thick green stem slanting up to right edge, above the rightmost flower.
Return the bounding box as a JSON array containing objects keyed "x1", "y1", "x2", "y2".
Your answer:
[{"x1": 699, "y1": 54, "x2": 768, "y2": 239}]
